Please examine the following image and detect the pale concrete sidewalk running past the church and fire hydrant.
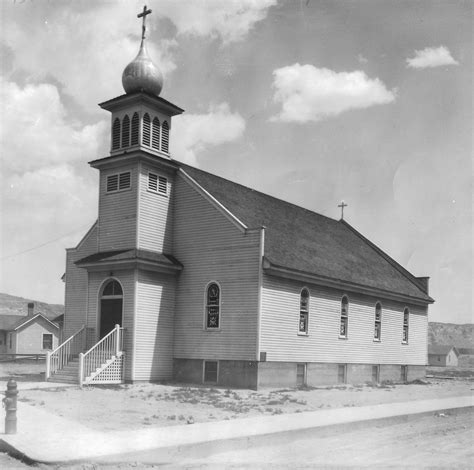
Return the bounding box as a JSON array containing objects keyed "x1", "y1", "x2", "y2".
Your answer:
[{"x1": 0, "y1": 396, "x2": 474, "y2": 463}]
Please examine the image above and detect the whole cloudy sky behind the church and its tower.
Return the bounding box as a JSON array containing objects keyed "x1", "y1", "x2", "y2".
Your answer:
[{"x1": 0, "y1": 0, "x2": 474, "y2": 323}]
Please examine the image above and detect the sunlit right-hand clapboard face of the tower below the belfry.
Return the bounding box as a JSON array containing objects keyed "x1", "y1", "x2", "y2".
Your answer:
[{"x1": 138, "y1": 164, "x2": 173, "y2": 253}]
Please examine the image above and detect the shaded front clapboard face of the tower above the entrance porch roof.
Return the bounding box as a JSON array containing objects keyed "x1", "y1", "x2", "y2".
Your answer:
[{"x1": 99, "y1": 165, "x2": 138, "y2": 251}]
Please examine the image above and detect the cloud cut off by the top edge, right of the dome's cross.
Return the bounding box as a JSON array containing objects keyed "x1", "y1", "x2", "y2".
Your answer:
[{"x1": 159, "y1": 0, "x2": 277, "y2": 43}]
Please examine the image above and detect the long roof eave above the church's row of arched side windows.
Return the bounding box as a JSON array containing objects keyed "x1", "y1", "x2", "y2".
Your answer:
[{"x1": 263, "y1": 258, "x2": 434, "y2": 306}]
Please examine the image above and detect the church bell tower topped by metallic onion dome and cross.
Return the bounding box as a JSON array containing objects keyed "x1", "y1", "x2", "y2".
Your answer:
[{"x1": 90, "y1": 7, "x2": 183, "y2": 253}]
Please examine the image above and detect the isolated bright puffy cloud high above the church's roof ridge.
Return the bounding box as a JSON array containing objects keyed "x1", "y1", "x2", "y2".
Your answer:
[{"x1": 270, "y1": 64, "x2": 396, "y2": 123}]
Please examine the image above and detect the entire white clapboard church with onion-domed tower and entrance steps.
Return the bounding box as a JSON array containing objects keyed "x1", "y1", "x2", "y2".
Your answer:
[{"x1": 47, "y1": 10, "x2": 433, "y2": 389}]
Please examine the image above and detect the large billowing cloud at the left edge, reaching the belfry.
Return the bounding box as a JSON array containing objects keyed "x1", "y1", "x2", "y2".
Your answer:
[{"x1": 0, "y1": 78, "x2": 108, "y2": 173}]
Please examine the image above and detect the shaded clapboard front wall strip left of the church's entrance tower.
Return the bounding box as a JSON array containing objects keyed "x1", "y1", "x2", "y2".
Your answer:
[{"x1": 63, "y1": 224, "x2": 98, "y2": 339}]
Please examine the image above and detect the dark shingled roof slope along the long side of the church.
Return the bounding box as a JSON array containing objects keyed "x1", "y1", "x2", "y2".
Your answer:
[{"x1": 179, "y1": 163, "x2": 433, "y2": 303}]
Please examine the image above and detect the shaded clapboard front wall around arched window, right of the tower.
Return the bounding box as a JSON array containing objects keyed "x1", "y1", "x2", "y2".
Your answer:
[{"x1": 174, "y1": 176, "x2": 260, "y2": 360}]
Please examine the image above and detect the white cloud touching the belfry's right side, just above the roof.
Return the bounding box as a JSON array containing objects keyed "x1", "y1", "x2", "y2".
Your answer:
[{"x1": 171, "y1": 103, "x2": 245, "y2": 164}]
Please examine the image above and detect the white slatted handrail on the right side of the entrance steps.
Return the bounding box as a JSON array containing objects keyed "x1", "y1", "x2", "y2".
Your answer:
[{"x1": 79, "y1": 325, "x2": 123, "y2": 386}]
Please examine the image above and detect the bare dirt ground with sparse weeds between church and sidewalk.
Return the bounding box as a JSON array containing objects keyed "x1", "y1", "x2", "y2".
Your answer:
[{"x1": 0, "y1": 362, "x2": 474, "y2": 431}]
